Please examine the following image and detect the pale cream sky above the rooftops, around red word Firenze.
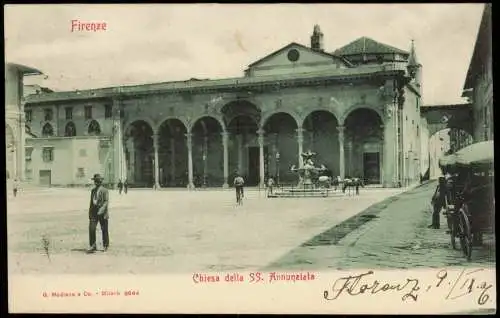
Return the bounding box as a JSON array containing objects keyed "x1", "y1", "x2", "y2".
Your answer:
[{"x1": 4, "y1": 3, "x2": 483, "y2": 105}]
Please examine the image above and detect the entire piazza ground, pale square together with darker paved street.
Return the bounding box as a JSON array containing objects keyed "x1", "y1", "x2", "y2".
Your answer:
[{"x1": 8, "y1": 184, "x2": 495, "y2": 274}]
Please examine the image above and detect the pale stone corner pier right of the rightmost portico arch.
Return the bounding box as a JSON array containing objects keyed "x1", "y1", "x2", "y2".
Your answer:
[{"x1": 382, "y1": 105, "x2": 398, "y2": 188}]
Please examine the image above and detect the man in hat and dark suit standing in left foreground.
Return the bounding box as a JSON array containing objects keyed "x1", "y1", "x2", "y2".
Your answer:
[{"x1": 87, "y1": 174, "x2": 109, "y2": 253}]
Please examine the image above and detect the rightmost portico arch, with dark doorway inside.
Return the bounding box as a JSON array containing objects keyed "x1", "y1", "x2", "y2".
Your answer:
[{"x1": 342, "y1": 106, "x2": 384, "y2": 184}]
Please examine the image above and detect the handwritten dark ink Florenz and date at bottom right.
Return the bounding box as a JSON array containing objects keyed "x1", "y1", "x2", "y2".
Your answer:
[{"x1": 323, "y1": 269, "x2": 493, "y2": 306}]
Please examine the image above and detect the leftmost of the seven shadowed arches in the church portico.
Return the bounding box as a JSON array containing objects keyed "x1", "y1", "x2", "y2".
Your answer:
[{"x1": 124, "y1": 120, "x2": 154, "y2": 187}]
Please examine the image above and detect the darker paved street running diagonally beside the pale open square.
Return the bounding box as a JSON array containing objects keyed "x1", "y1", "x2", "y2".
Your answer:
[{"x1": 267, "y1": 182, "x2": 495, "y2": 270}]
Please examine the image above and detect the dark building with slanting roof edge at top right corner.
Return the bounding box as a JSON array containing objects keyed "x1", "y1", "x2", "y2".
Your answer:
[{"x1": 462, "y1": 3, "x2": 494, "y2": 142}]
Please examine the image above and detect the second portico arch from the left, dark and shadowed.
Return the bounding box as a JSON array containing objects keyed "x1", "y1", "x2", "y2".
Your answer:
[{"x1": 157, "y1": 117, "x2": 188, "y2": 187}]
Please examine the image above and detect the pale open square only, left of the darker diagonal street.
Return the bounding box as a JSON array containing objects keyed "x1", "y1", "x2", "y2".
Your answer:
[{"x1": 8, "y1": 188, "x2": 401, "y2": 274}]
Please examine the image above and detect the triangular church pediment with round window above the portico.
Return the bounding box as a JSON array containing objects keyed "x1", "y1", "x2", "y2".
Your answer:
[{"x1": 249, "y1": 43, "x2": 345, "y2": 69}]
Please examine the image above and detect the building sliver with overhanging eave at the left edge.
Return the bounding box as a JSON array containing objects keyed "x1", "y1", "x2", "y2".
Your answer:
[{"x1": 5, "y1": 63, "x2": 42, "y2": 181}]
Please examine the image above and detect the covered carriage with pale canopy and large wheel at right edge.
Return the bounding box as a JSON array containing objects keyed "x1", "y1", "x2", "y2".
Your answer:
[{"x1": 439, "y1": 141, "x2": 495, "y2": 260}]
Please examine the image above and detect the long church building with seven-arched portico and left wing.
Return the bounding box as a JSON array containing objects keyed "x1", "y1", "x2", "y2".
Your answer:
[{"x1": 22, "y1": 26, "x2": 425, "y2": 187}]
